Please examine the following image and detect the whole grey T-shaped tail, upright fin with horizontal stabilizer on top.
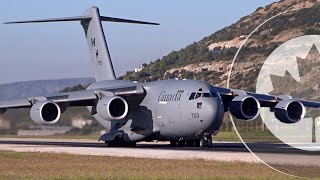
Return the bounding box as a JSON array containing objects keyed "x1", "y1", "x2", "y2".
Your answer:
[{"x1": 5, "y1": 7, "x2": 159, "y2": 82}]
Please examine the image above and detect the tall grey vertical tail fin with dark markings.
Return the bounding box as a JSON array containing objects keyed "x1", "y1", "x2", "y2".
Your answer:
[{"x1": 81, "y1": 7, "x2": 116, "y2": 82}]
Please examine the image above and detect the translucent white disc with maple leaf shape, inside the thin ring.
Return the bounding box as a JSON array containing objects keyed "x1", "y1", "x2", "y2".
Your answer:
[{"x1": 256, "y1": 35, "x2": 320, "y2": 151}]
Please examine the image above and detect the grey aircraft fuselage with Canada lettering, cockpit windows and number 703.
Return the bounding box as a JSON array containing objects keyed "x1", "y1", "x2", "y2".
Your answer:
[{"x1": 88, "y1": 80, "x2": 224, "y2": 141}]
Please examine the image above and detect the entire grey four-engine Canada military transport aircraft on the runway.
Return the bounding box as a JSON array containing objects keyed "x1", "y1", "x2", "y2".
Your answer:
[{"x1": 0, "y1": 7, "x2": 320, "y2": 147}]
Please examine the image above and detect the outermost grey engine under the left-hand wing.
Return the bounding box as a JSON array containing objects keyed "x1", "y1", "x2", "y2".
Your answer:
[{"x1": 30, "y1": 101, "x2": 61, "y2": 125}]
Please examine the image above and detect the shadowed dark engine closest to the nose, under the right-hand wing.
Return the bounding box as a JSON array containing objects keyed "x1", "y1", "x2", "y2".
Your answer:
[{"x1": 229, "y1": 95, "x2": 260, "y2": 120}]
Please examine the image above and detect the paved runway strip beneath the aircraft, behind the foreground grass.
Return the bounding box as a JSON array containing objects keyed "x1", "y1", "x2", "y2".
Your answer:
[{"x1": 0, "y1": 138, "x2": 320, "y2": 167}]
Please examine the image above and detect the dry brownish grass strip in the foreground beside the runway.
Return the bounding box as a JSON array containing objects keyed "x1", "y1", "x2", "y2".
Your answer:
[{"x1": 0, "y1": 151, "x2": 309, "y2": 179}]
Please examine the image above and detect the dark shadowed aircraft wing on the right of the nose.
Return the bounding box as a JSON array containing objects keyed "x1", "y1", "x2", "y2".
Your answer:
[{"x1": 213, "y1": 86, "x2": 320, "y2": 110}]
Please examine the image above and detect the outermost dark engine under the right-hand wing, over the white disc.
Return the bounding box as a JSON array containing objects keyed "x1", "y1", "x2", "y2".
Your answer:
[{"x1": 274, "y1": 99, "x2": 306, "y2": 124}]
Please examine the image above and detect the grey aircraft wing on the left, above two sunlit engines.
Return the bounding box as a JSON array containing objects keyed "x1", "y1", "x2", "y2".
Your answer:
[{"x1": 0, "y1": 84, "x2": 145, "y2": 112}]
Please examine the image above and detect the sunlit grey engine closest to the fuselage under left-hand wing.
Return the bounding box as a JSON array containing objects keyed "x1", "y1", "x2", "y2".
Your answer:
[{"x1": 97, "y1": 96, "x2": 129, "y2": 121}]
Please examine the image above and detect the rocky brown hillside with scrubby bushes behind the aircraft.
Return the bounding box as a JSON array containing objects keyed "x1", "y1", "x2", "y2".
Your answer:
[{"x1": 122, "y1": 0, "x2": 320, "y2": 93}]
